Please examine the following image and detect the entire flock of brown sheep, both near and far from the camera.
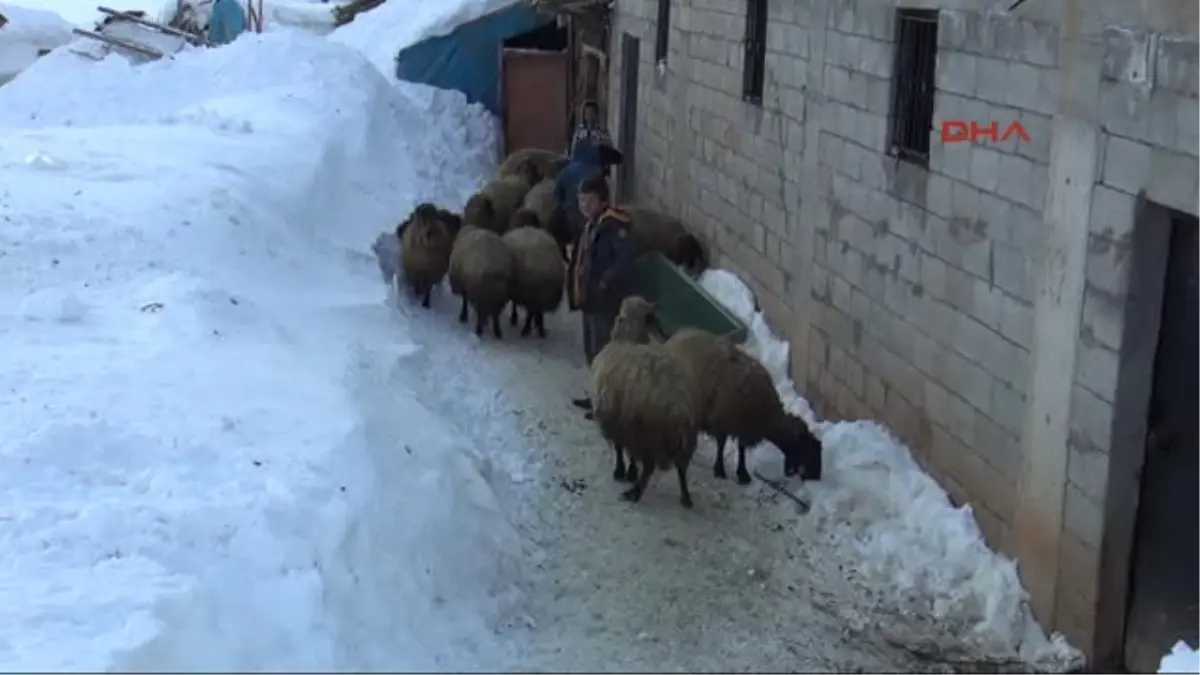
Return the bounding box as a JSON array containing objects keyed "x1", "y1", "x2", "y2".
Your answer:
[{"x1": 376, "y1": 150, "x2": 822, "y2": 508}]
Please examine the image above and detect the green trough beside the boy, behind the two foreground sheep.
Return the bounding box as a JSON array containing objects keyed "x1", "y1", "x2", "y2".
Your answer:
[{"x1": 632, "y1": 251, "x2": 748, "y2": 345}]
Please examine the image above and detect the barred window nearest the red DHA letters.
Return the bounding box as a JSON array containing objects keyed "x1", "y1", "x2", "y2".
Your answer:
[{"x1": 889, "y1": 10, "x2": 938, "y2": 166}]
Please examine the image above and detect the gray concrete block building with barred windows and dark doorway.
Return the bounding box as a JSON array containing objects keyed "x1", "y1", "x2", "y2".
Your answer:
[{"x1": 607, "y1": 0, "x2": 1200, "y2": 669}]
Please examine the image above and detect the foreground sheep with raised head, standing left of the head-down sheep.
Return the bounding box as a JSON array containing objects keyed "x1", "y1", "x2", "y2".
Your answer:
[{"x1": 592, "y1": 295, "x2": 700, "y2": 508}]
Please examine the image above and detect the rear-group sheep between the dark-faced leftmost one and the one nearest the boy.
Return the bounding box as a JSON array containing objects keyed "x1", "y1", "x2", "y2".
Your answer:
[{"x1": 450, "y1": 225, "x2": 516, "y2": 339}]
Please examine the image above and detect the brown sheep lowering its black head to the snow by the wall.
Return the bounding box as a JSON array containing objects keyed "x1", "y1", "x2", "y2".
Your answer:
[{"x1": 664, "y1": 328, "x2": 822, "y2": 485}]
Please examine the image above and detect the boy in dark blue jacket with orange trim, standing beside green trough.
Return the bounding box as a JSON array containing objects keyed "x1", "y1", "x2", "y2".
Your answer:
[{"x1": 566, "y1": 173, "x2": 637, "y2": 419}]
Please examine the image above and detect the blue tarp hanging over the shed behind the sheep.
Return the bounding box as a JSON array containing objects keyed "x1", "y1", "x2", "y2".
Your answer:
[{"x1": 396, "y1": 4, "x2": 553, "y2": 115}]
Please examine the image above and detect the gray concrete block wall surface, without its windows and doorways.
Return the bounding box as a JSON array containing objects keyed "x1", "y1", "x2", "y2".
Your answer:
[{"x1": 610, "y1": 0, "x2": 1200, "y2": 651}]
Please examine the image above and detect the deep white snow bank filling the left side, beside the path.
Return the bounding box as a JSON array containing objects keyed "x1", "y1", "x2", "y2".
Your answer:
[{"x1": 0, "y1": 34, "x2": 525, "y2": 670}]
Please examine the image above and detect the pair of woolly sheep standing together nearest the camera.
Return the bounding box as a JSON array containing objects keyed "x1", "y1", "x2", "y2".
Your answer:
[{"x1": 592, "y1": 295, "x2": 822, "y2": 508}]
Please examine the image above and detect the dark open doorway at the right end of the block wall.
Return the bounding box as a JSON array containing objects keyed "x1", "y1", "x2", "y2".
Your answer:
[{"x1": 1124, "y1": 213, "x2": 1200, "y2": 673}]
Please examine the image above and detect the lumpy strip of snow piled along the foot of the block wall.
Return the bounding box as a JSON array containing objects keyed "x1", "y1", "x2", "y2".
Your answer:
[{"x1": 701, "y1": 269, "x2": 1082, "y2": 670}]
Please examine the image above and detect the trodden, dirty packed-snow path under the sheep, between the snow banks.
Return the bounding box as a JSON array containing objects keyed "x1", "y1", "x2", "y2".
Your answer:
[{"x1": 394, "y1": 293, "x2": 912, "y2": 671}]
